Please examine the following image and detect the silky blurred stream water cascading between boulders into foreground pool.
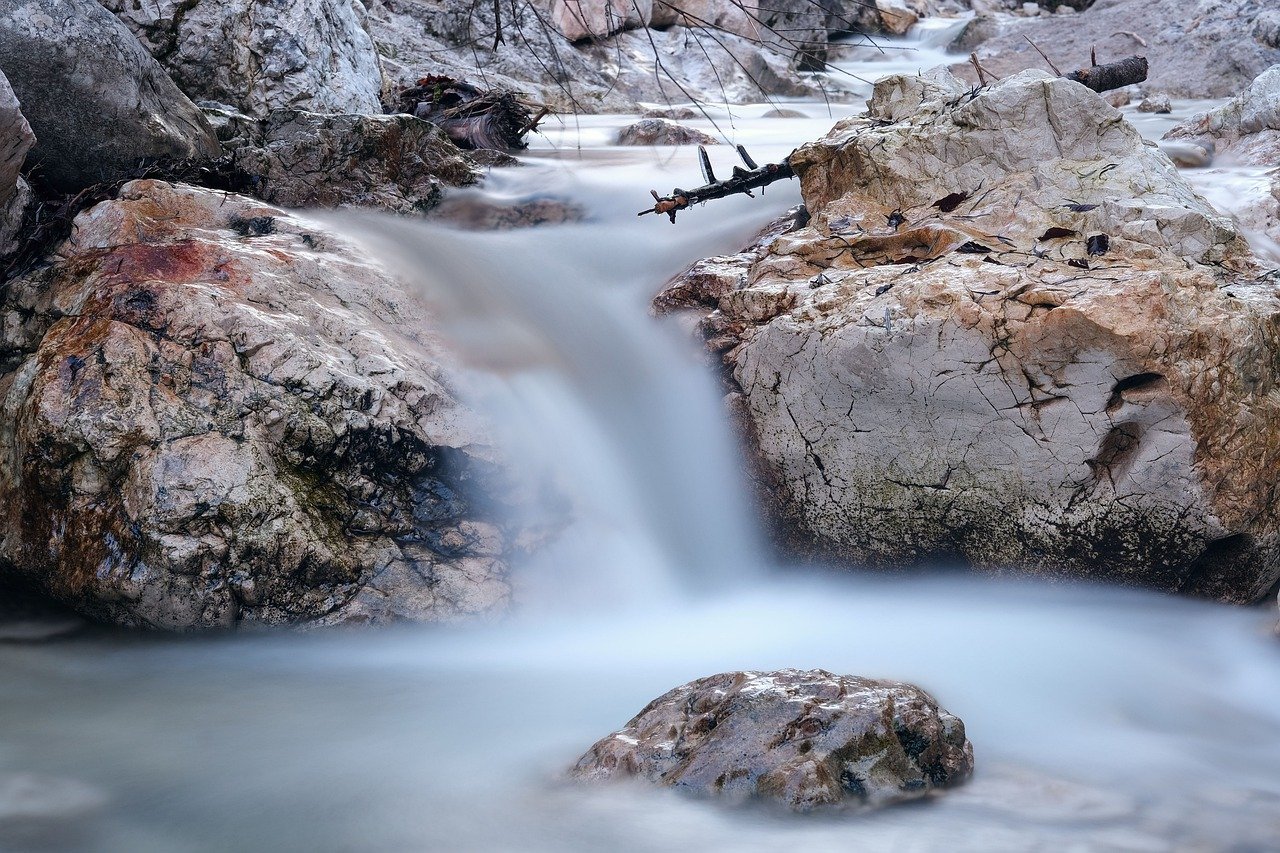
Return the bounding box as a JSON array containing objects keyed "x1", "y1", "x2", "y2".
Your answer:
[{"x1": 0, "y1": 19, "x2": 1280, "y2": 853}]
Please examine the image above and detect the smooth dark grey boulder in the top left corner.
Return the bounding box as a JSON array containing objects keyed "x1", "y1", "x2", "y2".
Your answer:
[{"x1": 0, "y1": 0, "x2": 220, "y2": 192}]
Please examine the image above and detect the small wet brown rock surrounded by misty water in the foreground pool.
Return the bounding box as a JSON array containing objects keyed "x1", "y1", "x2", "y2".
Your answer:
[{"x1": 571, "y1": 670, "x2": 973, "y2": 811}]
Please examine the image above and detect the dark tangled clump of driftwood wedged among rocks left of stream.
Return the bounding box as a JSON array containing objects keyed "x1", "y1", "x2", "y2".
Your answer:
[{"x1": 398, "y1": 76, "x2": 548, "y2": 150}]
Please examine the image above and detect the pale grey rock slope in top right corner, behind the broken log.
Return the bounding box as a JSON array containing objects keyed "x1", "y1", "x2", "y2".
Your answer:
[{"x1": 952, "y1": 0, "x2": 1280, "y2": 97}]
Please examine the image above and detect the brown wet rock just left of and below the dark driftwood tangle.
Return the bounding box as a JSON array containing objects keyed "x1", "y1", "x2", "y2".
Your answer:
[{"x1": 227, "y1": 110, "x2": 480, "y2": 213}]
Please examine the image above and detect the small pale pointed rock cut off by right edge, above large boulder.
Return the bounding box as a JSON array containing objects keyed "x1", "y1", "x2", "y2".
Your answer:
[{"x1": 1165, "y1": 64, "x2": 1280, "y2": 165}]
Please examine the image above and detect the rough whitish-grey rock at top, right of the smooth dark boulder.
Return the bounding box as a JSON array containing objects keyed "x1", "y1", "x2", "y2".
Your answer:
[{"x1": 102, "y1": 0, "x2": 381, "y2": 117}]
